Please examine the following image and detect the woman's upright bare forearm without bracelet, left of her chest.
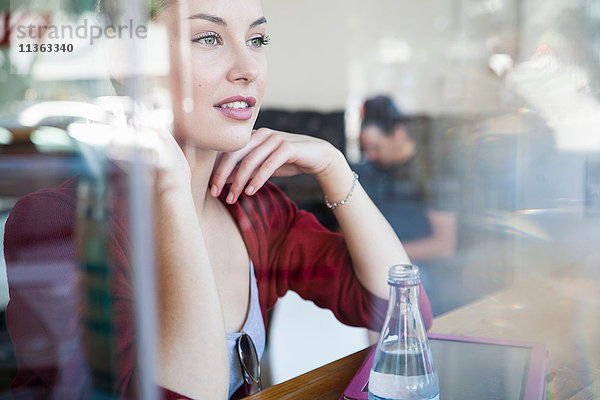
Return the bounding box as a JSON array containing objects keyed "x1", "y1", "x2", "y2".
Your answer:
[{"x1": 157, "y1": 194, "x2": 229, "y2": 399}]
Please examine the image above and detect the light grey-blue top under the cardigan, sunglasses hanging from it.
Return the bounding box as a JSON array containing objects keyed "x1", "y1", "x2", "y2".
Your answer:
[{"x1": 227, "y1": 261, "x2": 265, "y2": 397}]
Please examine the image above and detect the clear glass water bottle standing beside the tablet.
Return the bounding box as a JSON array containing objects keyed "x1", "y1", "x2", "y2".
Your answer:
[{"x1": 369, "y1": 264, "x2": 440, "y2": 400}]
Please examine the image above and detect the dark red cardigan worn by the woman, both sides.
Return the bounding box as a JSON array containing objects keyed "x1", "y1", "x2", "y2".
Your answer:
[{"x1": 4, "y1": 179, "x2": 432, "y2": 399}]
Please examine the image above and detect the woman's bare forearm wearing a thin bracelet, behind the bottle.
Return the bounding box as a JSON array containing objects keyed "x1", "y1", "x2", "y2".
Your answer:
[{"x1": 315, "y1": 150, "x2": 410, "y2": 298}]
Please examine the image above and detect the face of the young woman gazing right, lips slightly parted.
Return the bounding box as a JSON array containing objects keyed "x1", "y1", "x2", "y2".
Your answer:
[{"x1": 159, "y1": 0, "x2": 267, "y2": 151}]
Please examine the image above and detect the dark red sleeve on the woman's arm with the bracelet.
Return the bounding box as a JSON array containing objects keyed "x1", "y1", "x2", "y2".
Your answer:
[{"x1": 248, "y1": 185, "x2": 432, "y2": 330}]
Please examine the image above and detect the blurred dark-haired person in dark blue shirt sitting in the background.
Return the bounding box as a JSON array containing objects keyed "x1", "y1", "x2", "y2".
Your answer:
[{"x1": 354, "y1": 96, "x2": 457, "y2": 314}]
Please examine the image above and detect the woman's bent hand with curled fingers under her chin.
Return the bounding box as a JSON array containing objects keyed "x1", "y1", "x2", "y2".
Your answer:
[{"x1": 210, "y1": 128, "x2": 343, "y2": 204}]
